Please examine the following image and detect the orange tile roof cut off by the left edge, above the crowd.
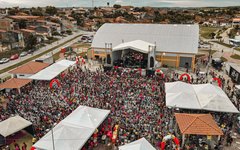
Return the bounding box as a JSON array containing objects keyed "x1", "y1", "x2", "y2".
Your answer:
[{"x1": 0, "y1": 78, "x2": 32, "y2": 89}]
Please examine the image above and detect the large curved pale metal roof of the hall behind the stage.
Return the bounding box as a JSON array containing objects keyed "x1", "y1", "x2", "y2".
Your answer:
[{"x1": 92, "y1": 23, "x2": 199, "y2": 54}]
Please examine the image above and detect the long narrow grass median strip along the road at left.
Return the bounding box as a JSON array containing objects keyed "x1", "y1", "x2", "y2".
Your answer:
[{"x1": 0, "y1": 35, "x2": 81, "y2": 74}]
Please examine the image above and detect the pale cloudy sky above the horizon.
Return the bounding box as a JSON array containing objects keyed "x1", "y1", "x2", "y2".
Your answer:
[{"x1": 0, "y1": 0, "x2": 240, "y2": 8}]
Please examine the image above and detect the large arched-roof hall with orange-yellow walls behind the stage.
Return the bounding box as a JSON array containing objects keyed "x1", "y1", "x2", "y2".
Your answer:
[{"x1": 92, "y1": 23, "x2": 199, "y2": 68}]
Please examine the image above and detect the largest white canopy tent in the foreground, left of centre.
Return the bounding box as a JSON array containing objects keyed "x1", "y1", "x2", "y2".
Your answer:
[{"x1": 34, "y1": 106, "x2": 110, "y2": 150}]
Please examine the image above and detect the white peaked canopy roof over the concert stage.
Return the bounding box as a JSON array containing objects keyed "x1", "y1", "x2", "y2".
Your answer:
[{"x1": 113, "y1": 40, "x2": 154, "y2": 53}]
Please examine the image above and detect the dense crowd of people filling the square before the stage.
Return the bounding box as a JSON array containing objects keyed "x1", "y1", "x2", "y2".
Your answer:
[{"x1": 0, "y1": 61, "x2": 238, "y2": 149}]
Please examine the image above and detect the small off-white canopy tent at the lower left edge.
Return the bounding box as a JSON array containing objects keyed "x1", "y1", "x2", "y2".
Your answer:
[{"x1": 0, "y1": 116, "x2": 32, "y2": 137}]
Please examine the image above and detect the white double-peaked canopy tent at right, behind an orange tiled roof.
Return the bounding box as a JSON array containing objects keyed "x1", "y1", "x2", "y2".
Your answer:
[{"x1": 165, "y1": 81, "x2": 239, "y2": 113}]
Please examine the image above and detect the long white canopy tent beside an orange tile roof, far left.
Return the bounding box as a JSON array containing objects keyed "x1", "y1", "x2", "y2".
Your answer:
[{"x1": 29, "y1": 59, "x2": 75, "y2": 80}]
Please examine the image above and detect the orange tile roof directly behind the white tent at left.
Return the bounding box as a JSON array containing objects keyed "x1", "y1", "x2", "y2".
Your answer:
[{"x1": 9, "y1": 61, "x2": 49, "y2": 74}]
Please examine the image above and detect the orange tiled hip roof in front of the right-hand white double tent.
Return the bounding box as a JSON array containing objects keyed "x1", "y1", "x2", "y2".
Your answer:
[{"x1": 175, "y1": 113, "x2": 223, "y2": 135}]
